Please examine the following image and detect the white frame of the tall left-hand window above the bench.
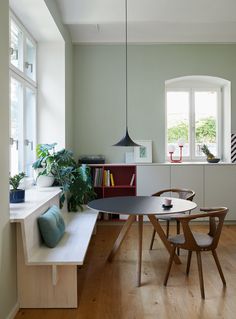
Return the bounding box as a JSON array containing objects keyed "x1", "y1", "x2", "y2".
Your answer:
[{"x1": 9, "y1": 11, "x2": 38, "y2": 180}]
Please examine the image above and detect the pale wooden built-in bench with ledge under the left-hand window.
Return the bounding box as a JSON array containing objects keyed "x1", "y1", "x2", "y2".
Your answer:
[{"x1": 10, "y1": 188, "x2": 98, "y2": 308}]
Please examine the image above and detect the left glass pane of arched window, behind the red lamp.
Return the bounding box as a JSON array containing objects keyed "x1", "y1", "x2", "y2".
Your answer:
[{"x1": 167, "y1": 91, "x2": 189, "y2": 156}]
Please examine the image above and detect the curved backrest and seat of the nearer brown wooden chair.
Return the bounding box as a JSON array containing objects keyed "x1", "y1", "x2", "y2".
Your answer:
[{"x1": 176, "y1": 207, "x2": 228, "y2": 251}]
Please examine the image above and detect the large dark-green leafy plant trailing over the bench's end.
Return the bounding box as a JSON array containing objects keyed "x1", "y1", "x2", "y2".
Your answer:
[{"x1": 33, "y1": 143, "x2": 95, "y2": 211}]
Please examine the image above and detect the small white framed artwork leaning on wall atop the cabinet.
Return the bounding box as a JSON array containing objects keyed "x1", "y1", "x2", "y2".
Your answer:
[{"x1": 134, "y1": 140, "x2": 152, "y2": 163}]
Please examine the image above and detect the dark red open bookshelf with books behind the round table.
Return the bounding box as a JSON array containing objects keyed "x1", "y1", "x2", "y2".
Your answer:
[{"x1": 89, "y1": 164, "x2": 137, "y2": 220}]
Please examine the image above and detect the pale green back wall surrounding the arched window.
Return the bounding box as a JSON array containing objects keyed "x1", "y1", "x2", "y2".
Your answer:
[{"x1": 74, "y1": 44, "x2": 236, "y2": 162}]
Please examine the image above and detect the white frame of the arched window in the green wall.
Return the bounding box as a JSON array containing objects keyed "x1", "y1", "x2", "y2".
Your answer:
[{"x1": 165, "y1": 84, "x2": 223, "y2": 162}]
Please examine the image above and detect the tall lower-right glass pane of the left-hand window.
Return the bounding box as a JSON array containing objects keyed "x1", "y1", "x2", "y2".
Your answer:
[{"x1": 25, "y1": 87, "x2": 36, "y2": 176}]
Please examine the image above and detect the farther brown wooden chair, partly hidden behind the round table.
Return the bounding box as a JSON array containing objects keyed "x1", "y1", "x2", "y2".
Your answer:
[{"x1": 150, "y1": 188, "x2": 195, "y2": 255}]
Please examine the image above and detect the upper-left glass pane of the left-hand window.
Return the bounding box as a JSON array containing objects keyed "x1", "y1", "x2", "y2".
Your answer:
[{"x1": 10, "y1": 20, "x2": 23, "y2": 71}]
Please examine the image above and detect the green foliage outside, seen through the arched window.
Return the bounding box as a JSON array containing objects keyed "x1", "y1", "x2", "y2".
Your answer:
[{"x1": 168, "y1": 117, "x2": 216, "y2": 143}]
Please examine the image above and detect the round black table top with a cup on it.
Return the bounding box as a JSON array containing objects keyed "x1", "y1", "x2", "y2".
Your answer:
[{"x1": 88, "y1": 196, "x2": 197, "y2": 215}]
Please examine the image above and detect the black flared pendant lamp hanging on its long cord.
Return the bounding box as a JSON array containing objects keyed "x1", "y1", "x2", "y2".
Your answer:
[{"x1": 113, "y1": 0, "x2": 140, "y2": 146}]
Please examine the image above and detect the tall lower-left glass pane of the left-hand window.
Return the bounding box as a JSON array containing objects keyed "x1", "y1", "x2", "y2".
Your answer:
[{"x1": 10, "y1": 78, "x2": 23, "y2": 175}]
